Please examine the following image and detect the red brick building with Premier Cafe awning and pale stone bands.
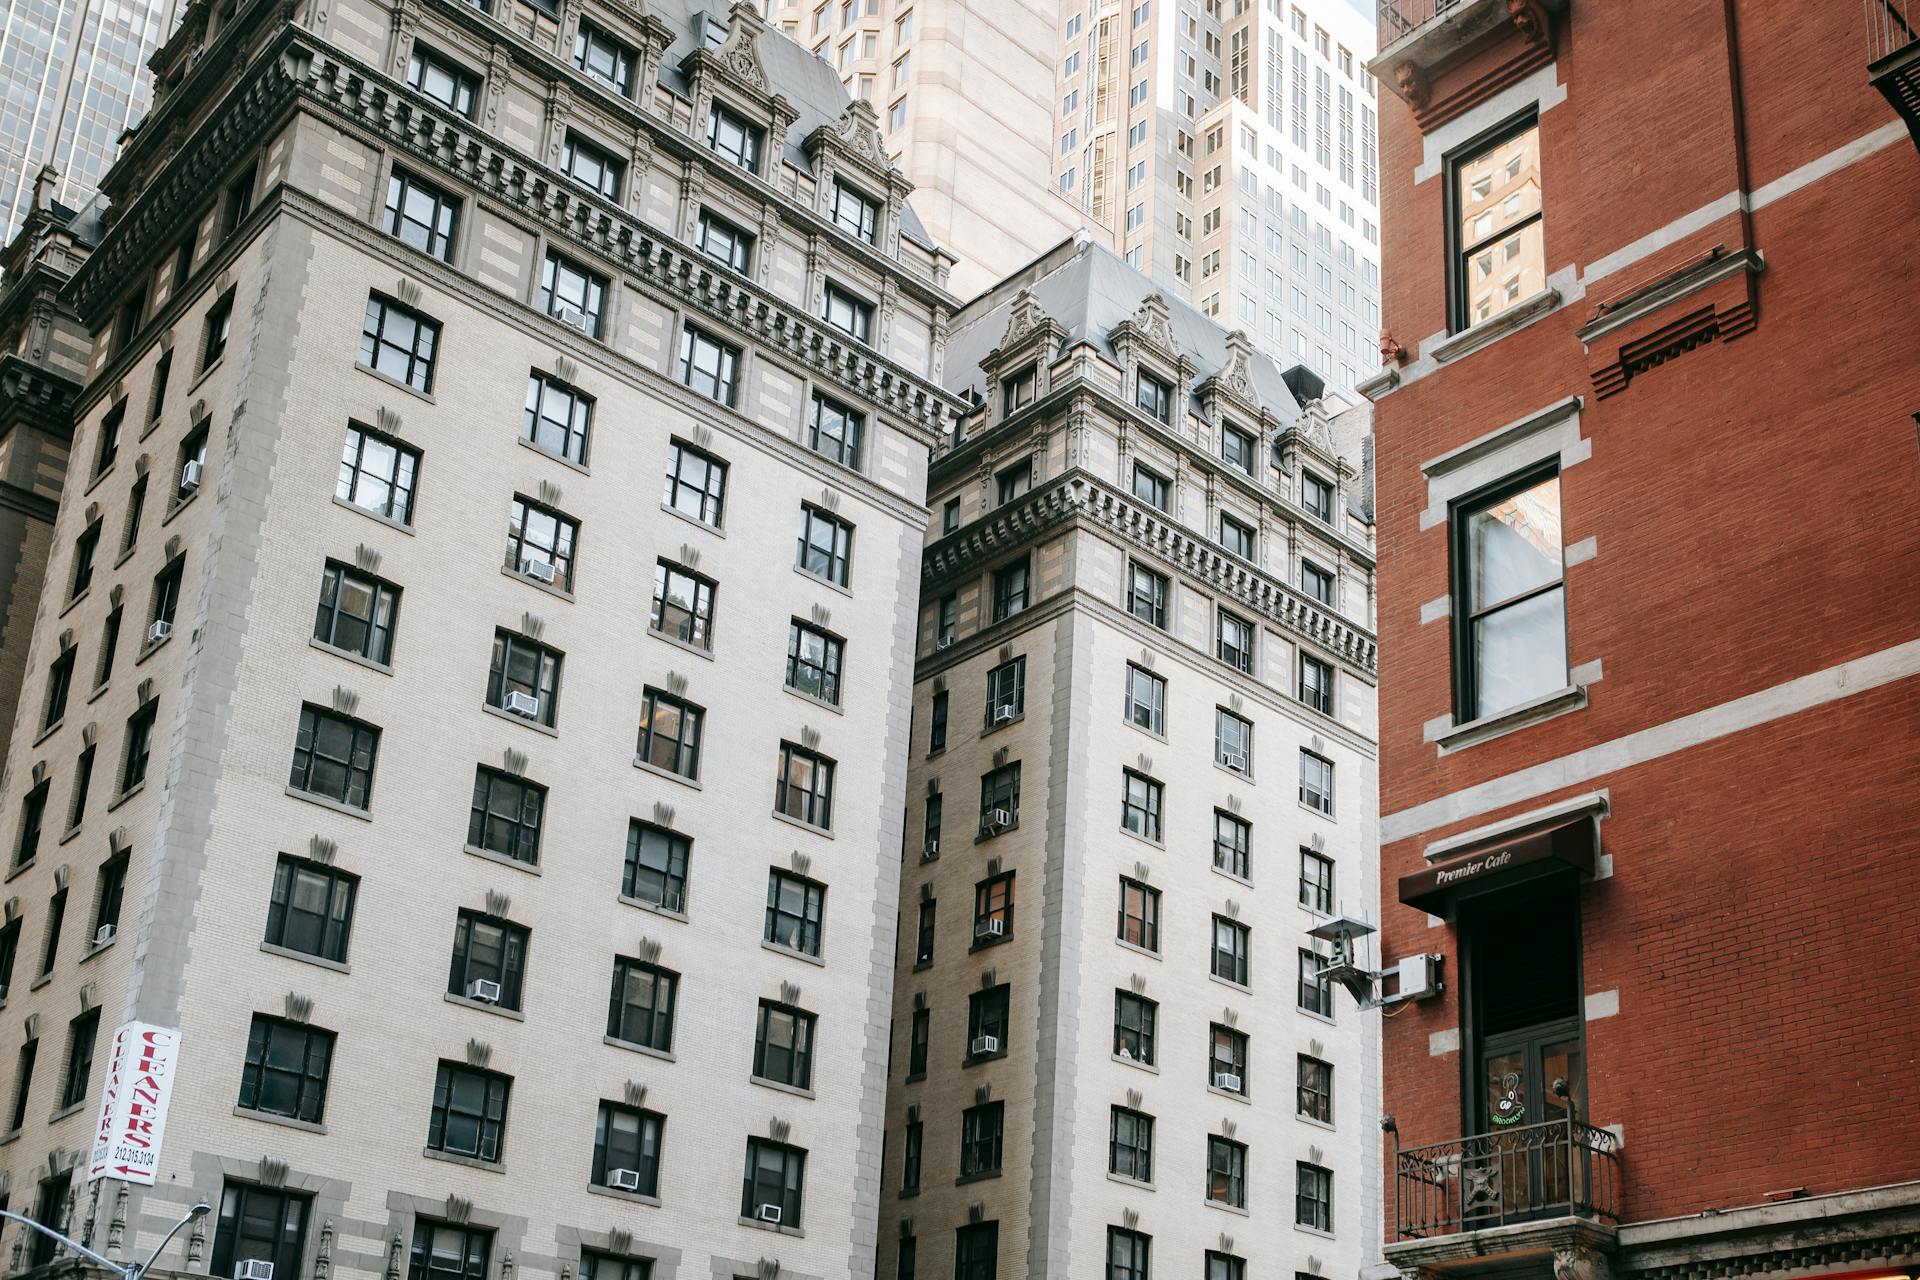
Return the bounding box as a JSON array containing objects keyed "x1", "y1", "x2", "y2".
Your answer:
[{"x1": 1363, "y1": 0, "x2": 1920, "y2": 1280}]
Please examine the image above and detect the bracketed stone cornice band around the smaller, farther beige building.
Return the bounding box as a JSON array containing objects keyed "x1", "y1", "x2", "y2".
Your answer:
[{"x1": 920, "y1": 468, "x2": 1379, "y2": 677}]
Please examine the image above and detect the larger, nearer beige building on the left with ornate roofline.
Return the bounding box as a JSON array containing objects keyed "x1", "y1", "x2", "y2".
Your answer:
[{"x1": 0, "y1": 0, "x2": 958, "y2": 1280}]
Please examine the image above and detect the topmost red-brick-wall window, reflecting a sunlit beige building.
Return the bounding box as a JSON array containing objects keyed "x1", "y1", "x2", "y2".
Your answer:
[{"x1": 1448, "y1": 113, "x2": 1546, "y2": 332}]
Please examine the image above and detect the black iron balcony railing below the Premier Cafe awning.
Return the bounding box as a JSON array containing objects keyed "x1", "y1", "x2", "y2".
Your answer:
[{"x1": 1394, "y1": 1119, "x2": 1620, "y2": 1240}]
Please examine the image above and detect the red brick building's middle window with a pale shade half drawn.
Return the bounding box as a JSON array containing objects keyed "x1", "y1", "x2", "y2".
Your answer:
[{"x1": 1453, "y1": 470, "x2": 1567, "y2": 722}]
